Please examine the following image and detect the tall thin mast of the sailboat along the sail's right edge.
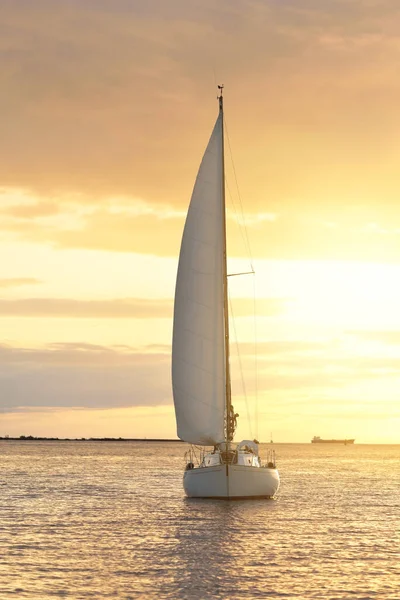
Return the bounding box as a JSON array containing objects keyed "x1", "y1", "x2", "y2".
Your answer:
[{"x1": 218, "y1": 85, "x2": 234, "y2": 442}]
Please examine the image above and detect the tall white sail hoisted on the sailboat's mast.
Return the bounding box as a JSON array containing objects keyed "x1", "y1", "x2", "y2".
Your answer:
[{"x1": 172, "y1": 113, "x2": 225, "y2": 445}]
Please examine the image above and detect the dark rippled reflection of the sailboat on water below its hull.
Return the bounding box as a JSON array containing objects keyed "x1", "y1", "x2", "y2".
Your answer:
[{"x1": 176, "y1": 500, "x2": 280, "y2": 598}]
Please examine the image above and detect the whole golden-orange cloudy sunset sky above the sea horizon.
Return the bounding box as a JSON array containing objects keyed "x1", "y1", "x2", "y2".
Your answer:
[{"x1": 0, "y1": 0, "x2": 400, "y2": 443}]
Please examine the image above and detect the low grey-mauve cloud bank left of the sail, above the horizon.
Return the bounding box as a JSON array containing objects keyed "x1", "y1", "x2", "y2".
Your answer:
[{"x1": 0, "y1": 344, "x2": 171, "y2": 412}]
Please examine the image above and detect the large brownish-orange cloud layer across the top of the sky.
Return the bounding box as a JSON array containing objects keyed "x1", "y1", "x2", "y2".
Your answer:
[{"x1": 0, "y1": 0, "x2": 399, "y2": 220}]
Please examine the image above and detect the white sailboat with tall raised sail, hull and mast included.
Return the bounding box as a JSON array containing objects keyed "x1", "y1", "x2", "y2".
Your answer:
[{"x1": 172, "y1": 86, "x2": 279, "y2": 499}]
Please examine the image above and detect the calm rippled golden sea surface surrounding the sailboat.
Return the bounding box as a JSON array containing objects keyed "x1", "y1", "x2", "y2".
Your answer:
[{"x1": 0, "y1": 441, "x2": 400, "y2": 600}]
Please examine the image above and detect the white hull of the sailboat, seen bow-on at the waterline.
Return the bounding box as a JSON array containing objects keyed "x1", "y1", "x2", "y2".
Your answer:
[{"x1": 183, "y1": 464, "x2": 279, "y2": 500}]
